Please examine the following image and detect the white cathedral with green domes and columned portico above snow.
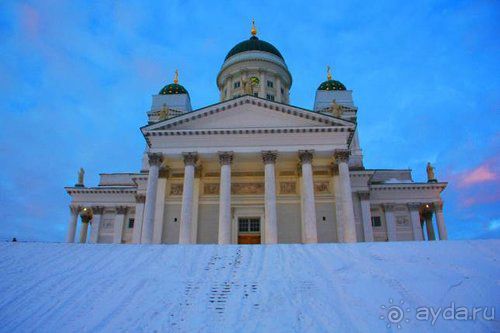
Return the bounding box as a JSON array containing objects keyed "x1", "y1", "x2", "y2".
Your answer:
[{"x1": 66, "y1": 22, "x2": 447, "y2": 244}]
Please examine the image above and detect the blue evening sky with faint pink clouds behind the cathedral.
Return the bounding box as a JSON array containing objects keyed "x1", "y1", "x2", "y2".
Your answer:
[{"x1": 0, "y1": 0, "x2": 500, "y2": 241}]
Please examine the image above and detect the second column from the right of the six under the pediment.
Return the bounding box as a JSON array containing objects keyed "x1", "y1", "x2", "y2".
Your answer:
[{"x1": 299, "y1": 150, "x2": 318, "y2": 243}]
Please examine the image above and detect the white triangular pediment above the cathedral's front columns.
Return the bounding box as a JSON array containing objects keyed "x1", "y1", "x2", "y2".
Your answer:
[{"x1": 143, "y1": 96, "x2": 355, "y2": 132}]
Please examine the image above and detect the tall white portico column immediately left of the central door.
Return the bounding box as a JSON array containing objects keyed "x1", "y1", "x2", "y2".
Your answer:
[{"x1": 219, "y1": 152, "x2": 233, "y2": 244}]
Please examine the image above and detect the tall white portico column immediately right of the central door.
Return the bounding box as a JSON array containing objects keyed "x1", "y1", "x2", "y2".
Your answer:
[{"x1": 262, "y1": 151, "x2": 278, "y2": 244}]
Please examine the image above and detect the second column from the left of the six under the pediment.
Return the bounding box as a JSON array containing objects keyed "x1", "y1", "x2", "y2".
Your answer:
[{"x1": 179, "y1": 153, "x2": 198, "y2": 244}]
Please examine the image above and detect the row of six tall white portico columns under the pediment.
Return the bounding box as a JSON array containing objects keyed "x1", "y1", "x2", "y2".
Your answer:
[{"x1": 140, "y1": 150, "x2": 356, "y2": 244}]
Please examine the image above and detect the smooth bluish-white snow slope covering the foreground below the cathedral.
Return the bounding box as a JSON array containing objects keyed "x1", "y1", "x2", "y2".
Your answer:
[{"x1": 0, "y1": 240, "x2": 500, "y2": 332}]
